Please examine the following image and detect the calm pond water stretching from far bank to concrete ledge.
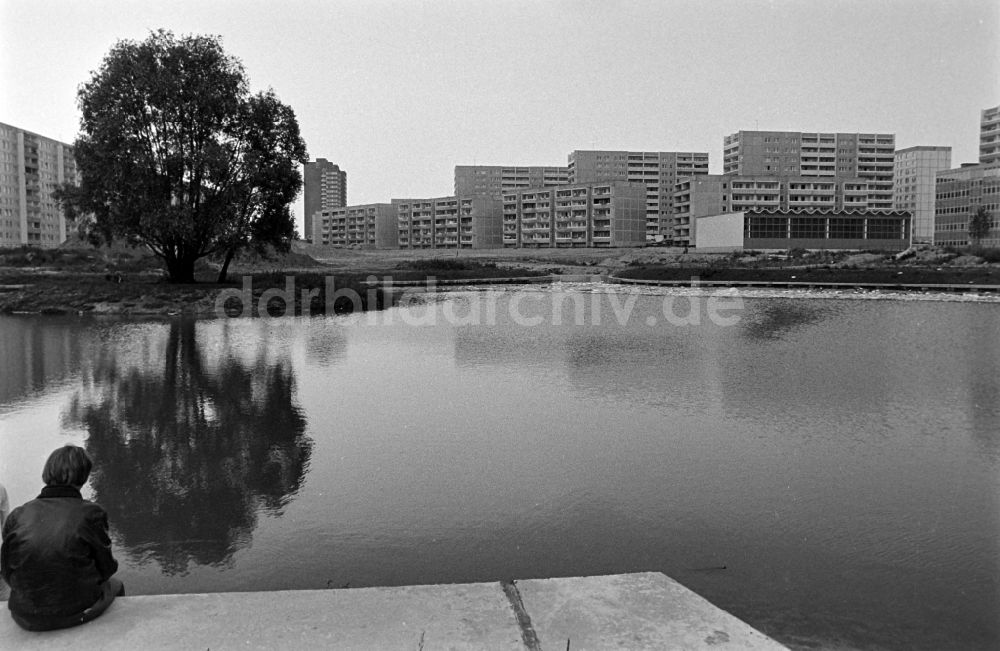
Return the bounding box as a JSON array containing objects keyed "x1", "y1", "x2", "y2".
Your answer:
[{"x1": 0, "y1": 288, "x2": 1000, "y2": 649}]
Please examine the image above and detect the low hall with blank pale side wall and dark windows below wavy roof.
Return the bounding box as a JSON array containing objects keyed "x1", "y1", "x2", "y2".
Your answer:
[{"x1": 698, "y1": 208, "x2": 910, "y2": 252}]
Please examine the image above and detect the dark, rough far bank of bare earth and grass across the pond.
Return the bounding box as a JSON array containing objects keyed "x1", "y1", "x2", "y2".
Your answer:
[{"x1": 0, "y1": 247, "x2": 1000, "y2": 316}]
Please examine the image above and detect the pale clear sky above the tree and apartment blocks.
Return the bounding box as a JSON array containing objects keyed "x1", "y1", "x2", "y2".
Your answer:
[{"x1": 0, "y1": 0, "x2": 1000, "y2": 234}]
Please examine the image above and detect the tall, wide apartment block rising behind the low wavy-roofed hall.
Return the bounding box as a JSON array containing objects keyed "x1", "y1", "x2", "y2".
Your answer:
[{"x1": 723, "y1": 131, "x2": 896, "y2": 210}]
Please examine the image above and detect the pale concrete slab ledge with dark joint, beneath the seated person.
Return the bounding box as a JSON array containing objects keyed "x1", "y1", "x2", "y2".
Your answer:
[{"x1": 0, "y1": 572, "x2": 785, "y2": 651}]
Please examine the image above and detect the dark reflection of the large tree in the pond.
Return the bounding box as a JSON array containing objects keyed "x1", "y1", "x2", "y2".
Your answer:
[{"x1": 68, "y1": 322, "x2": 312, "y2": 574}]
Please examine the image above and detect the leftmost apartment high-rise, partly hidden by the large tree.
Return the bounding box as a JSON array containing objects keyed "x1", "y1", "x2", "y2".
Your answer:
[{"x1": 0, "y1": 123, "x2": 80, "y2": 247}]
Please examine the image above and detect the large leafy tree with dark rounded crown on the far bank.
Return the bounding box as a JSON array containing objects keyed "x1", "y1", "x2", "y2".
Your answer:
[{"x1": 59, "y1": 30, "x2": 308, "y2": 282}]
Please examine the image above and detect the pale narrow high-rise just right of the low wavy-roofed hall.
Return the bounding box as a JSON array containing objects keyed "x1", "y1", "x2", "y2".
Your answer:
[{"x1": 892, "y1": 146, "x2": 951, "y2": 242}]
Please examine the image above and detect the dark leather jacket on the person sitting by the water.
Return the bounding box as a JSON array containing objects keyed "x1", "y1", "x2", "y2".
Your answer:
[{"x1": 0, "y1": 486, "x2": 118, "y2": 618}]
